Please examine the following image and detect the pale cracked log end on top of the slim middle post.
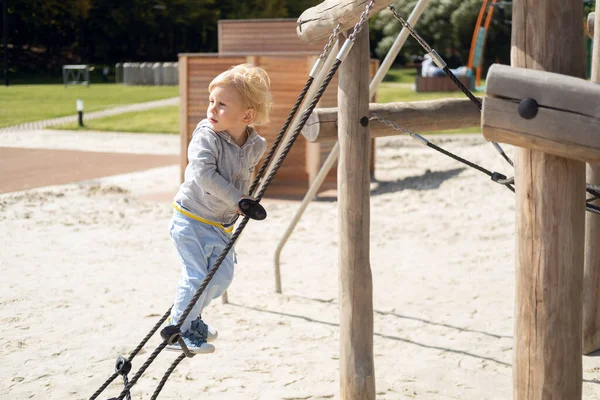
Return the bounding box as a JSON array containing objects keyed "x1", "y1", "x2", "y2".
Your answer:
[{"x1": 296, "y1": 0, "x2": 394, "y2": 43}]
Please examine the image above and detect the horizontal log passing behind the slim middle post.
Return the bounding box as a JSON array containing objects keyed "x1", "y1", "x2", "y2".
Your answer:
[{"x1": 302, "y1": 99, "x2": 481, "y2": 142}]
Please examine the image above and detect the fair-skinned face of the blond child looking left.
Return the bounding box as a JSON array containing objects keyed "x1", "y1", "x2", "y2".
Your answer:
[{"x1": 206, "y1": 86, "x2": 249, "y2": 136}]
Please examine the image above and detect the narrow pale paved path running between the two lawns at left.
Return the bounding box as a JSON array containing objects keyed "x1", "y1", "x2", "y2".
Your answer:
[{"x1": 0, "y1": 97, "x2": 179, "y2": 133}]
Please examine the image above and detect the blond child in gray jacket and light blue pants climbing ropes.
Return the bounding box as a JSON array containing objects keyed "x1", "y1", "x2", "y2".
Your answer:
[{"x1": 167, "y1": 64, "x2": 271, "y2": 353}]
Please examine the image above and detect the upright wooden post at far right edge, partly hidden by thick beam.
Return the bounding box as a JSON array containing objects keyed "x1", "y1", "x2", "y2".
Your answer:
[{"x1": 583, "y1": 0, "x2": 600, "y2": 354}]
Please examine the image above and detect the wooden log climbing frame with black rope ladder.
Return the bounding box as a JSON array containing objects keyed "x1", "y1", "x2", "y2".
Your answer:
[{"x1": 92, "y1": 0, "x2": 600, "y2": 399}]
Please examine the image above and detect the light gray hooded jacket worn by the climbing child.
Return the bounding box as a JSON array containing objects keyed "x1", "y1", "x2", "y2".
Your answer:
[{"x1": 174, "y1": 119, "x2": 267, "y2": 225}]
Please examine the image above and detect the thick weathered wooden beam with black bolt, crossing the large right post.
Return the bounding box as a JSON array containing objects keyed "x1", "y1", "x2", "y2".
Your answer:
[{"x1": 482, "y1": 65, "x2": 600, "y2": 162}]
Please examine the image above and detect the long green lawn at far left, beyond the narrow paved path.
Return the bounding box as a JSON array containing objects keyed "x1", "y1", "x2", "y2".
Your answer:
[{"x1": 0, "y1": 84, "x2": 179, "y2": 127}]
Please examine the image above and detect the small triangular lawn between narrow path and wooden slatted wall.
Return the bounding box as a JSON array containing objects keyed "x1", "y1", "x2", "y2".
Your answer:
[{"x1": 52, "y1": 106, "x2": 179, "y2": 134}]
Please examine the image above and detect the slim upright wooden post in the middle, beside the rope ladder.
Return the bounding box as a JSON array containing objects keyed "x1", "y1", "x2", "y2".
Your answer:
[{"x1": 338, "y1": 23, "x2": 375, "y2": 400}]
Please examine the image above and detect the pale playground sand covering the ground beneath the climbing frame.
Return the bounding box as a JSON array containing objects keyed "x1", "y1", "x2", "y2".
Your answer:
[{"x1": 0, "y1": 131, "x2": 600, "y2": 400}]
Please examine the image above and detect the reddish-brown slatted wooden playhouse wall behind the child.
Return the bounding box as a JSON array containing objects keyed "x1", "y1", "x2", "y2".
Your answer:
[{"x1": 179, "y1": 20, "x2": 378, "y2": 197}]
